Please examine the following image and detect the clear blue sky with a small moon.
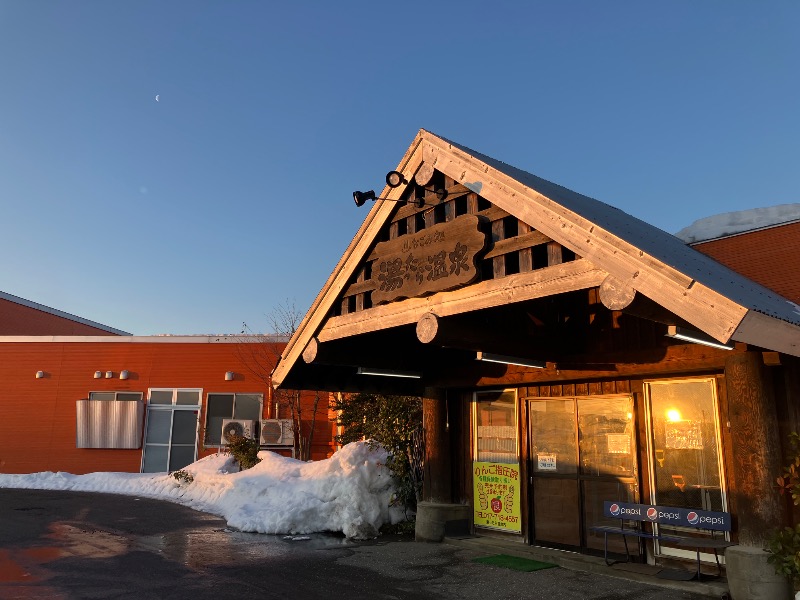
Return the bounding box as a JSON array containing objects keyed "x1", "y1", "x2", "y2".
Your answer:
[{"x1": 0, "y1": 0, "x2": 800, "y2": 335}]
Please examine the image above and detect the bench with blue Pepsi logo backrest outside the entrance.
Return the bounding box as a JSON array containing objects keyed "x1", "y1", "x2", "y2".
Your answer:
[{"x1": 589, "y1": 500, "x2": 736, "y2": 581}]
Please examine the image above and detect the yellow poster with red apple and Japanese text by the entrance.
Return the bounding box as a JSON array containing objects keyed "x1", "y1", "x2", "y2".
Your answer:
[{"x1": 472, "y1": 462, "x2": 522, "y2": 532}]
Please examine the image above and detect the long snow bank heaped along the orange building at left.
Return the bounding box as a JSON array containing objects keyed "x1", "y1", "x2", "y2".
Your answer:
[{"x1": 0, "y1": 442, "x2": 402, "y2": 539}]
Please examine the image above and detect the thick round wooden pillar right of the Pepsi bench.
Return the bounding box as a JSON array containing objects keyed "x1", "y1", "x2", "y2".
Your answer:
[{"x1": 725, "y1": 352, "x2": 783, "y2": 548}]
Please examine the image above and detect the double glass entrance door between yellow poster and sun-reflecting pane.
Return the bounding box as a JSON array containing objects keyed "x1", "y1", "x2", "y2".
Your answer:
[{"x1": 528, "y1": 396, "x2": 638, "y2": 552}]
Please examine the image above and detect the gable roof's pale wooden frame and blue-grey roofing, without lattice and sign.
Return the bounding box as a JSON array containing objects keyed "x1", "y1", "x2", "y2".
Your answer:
[{"x1": 273, "y1": 130, "x2": 800, "y2": 386}]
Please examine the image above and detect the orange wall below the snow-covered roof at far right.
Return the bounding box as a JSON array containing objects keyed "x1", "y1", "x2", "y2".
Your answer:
[{"x1": 692, "y1": 223, "x2": 800, "y2": 303}]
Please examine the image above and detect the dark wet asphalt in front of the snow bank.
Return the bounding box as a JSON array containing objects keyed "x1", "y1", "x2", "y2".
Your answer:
[{"x1": 0, "y1": 489, "x2": 702, "y2": 600}]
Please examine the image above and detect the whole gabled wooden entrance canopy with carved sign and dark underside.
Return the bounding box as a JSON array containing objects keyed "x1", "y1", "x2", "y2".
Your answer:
[{"x1": 273, "y1": 130, "x2": 800, "y2": 393}]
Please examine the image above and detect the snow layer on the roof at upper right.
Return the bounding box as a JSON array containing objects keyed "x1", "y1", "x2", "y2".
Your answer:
[{"x1": 675, "y1": 204, "x2": 800, "y2": 244}]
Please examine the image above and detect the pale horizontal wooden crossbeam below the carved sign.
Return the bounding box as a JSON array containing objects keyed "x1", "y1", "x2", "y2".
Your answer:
[{"x1": 317, "y1": 259, "x2": 607, "y2": 341}]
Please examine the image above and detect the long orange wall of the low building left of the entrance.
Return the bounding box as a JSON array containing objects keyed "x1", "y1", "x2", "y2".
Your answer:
[{"x1": 0, "y1": 338, "x2": 335, "y2": 474}]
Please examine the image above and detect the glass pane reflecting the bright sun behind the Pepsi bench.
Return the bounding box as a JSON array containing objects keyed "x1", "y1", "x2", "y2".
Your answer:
[{"x1": 645, "y1": 377, "x2": 728, "y2": 560}]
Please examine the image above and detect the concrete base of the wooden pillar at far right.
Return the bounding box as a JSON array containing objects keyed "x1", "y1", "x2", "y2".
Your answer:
[{"x1": 725, "y1": 546, "x2": 794, "y2": 600}]
